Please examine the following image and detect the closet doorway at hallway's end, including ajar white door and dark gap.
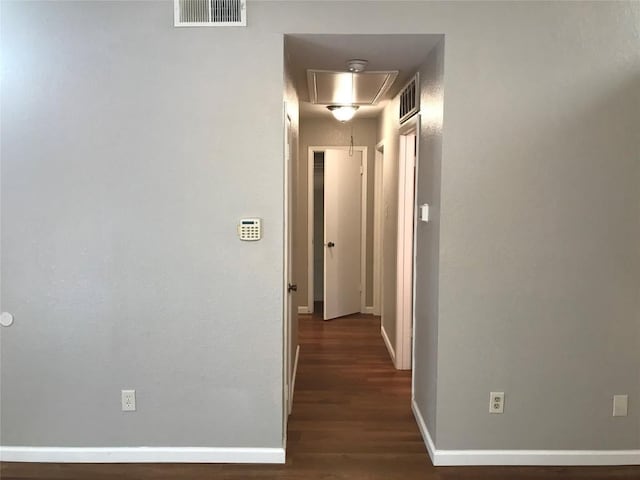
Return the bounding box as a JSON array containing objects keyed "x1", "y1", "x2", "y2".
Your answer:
[{"x1": 308, "y1": 147, "x2": 367, "y2": 320}]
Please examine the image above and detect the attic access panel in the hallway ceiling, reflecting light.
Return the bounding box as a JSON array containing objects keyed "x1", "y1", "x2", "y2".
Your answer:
[{"x1": 307, "y1": 70, "x2": 398, "y2": 105}]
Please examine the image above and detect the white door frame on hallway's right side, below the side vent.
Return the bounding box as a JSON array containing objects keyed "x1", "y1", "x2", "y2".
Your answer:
[{"x1": 395, "y1": 115, "x2": 420, "y2": 370}]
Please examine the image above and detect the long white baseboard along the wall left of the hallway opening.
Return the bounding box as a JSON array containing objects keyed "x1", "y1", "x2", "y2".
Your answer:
[{"x1": 0, "y1": 447, "x2": 285, "y2": 463}]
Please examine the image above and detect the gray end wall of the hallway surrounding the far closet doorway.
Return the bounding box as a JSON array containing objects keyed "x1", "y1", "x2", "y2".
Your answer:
[{"x1": 295, "y1": 118, "x2": 377, "y2": 305}]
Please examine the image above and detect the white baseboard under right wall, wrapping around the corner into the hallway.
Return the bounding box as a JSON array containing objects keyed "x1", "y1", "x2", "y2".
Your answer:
[{"x1": 411, "y1": 399, "x2": 640, "y2": 467}]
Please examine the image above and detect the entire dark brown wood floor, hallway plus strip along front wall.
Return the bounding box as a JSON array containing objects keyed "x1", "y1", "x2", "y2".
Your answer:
[{"x1": 0, "y1": 315, "x2": 640, "y2": 480}]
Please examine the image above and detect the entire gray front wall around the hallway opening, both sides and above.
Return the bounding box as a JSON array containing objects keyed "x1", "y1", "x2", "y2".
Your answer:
[{"x1": 0, "y1": 2, "x2": 640, "y2": 449}]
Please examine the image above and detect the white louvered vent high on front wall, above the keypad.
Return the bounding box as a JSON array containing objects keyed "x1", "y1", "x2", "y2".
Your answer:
[{"x1": 173, "y1": 0, "x2": 247, "y2": 27}]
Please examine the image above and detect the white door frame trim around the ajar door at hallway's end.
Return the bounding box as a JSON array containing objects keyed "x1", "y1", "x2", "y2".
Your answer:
[{"x1": 306, "y1": 145, "x2": 368, "y2": 313}]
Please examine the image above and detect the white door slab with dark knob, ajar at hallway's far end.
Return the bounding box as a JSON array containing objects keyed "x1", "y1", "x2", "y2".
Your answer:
[{"x1": 324, "y1": 150, "x2": 362, "y2": 320}]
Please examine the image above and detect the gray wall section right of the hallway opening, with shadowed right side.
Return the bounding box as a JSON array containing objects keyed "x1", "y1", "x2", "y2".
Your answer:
[{"x1": 437, "y1": 2, "x2": 640, "y2": 449}]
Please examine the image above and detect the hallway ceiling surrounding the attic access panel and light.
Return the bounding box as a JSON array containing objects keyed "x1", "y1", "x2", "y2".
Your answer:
[{"x1": 285, "y1": 34, "x2": 442, "y2": 118}]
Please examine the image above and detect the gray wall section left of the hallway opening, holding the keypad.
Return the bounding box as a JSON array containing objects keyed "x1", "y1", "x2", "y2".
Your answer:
[{"x1": 1, "y1": 2, "x2": 283, "y2": 447}]
